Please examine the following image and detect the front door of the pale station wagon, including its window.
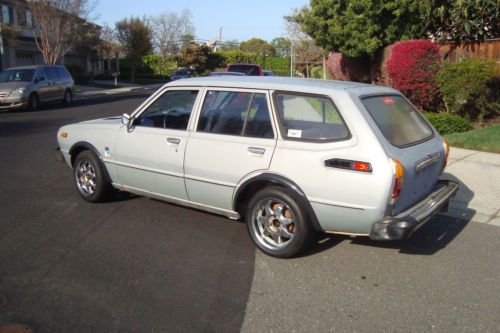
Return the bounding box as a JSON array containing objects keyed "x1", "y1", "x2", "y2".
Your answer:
[{"x1": 110, "y1": 88, "x2": 199, "y2": 200}]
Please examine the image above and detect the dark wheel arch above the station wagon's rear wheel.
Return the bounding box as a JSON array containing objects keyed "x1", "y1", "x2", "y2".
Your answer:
[{"x1": 233, "y1": 172, "x2": 323, "y2": 231}]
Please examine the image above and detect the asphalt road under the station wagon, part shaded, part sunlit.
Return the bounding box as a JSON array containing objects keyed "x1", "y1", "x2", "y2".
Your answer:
[{"x1": 0, "y1": 95, "x2": 500, "y2": 332}]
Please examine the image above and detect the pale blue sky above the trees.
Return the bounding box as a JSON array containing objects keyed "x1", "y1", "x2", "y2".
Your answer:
[{"x1": 95, "y1": 0, "x2": 309, "y2": 41}]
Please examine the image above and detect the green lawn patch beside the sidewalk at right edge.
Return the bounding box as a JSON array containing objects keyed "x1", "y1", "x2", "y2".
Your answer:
[{"x1": 444, "y1": 125, "x2": 500, "y2": 153}]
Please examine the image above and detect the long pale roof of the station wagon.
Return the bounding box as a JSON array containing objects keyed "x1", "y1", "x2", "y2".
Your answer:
[{"x1": 166, "y1": 75, "x2": 397, "y2": 94}]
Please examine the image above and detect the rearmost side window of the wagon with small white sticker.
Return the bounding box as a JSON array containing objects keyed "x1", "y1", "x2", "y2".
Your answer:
[{"x1": 275, "y1": 93, "x2": 349, "y2": 141}]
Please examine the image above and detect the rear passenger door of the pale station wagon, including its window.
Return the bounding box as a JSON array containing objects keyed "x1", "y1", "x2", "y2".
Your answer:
[{"x1": 184, "y1": 89, "x2": 276, "y2": 211}]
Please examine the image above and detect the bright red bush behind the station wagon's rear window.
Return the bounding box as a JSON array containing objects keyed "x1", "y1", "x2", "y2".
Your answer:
[{"x1": 387, "y1": 40, "x2": 441, "y2": 110}]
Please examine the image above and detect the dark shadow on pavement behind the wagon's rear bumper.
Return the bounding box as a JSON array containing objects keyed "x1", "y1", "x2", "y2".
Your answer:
[{"x1": 346, "y1": 173, "x2": 476, "y2": 255}]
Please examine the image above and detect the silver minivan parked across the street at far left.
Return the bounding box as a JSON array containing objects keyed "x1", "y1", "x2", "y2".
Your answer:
[{"x1": 0, "y1": 65, "x2": 74, "y2": 110}]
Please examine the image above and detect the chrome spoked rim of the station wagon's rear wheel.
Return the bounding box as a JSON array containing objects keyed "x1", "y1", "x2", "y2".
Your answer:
[{"x1": 250, "y1": 199, "x2": 295, "y2": 250}]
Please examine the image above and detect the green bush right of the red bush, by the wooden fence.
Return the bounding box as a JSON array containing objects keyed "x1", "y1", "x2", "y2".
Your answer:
[{"x1": 436, "y1": 59, "x2": 500, "y2": 120}]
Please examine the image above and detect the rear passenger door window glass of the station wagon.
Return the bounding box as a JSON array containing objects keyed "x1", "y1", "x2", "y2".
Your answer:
[{"x1": 197, "y1": 91, "x2": 273, "y2": 138}]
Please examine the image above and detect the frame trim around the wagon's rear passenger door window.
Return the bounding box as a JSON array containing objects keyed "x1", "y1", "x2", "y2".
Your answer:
[{"x1": 193, "y1": 86, "x2": 278, "y2": 140}]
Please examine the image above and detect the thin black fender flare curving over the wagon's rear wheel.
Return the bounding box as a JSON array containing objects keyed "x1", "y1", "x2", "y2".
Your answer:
[{"x1": 233, "y1": 172, "x2": 324, "y2": 231}]
